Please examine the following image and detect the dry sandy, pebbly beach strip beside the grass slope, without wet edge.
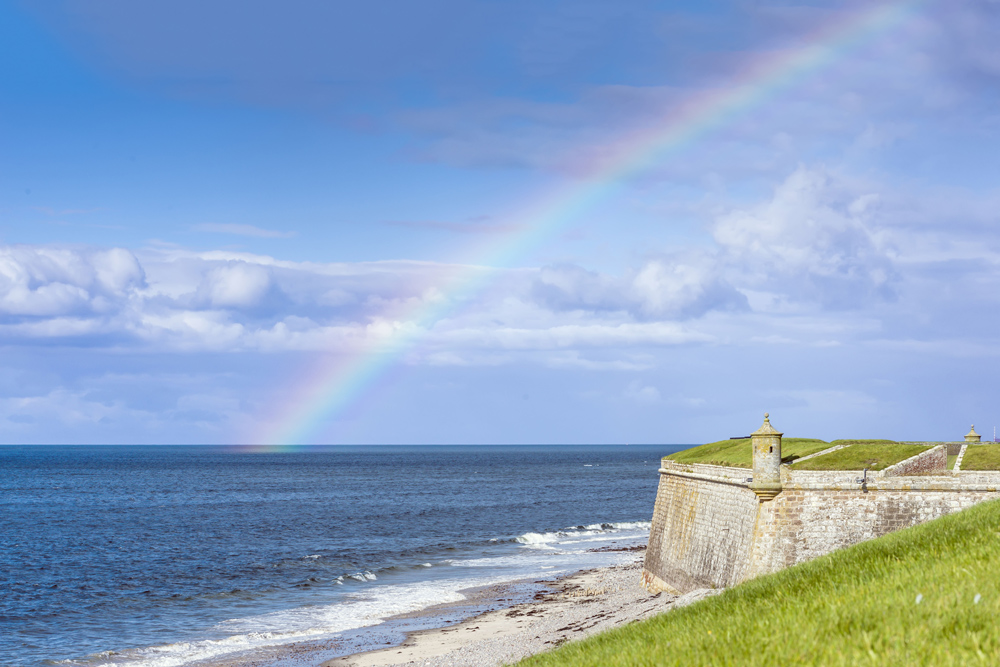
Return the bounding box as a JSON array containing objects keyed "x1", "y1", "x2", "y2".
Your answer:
[{"x1": 323, "y1": 552, "x2": 715, "y2": 667}]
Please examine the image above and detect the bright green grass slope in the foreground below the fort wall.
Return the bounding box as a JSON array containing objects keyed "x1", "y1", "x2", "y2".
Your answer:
[{"x1": 519, "y1": 502, "x2": 1000, "y2": 667}]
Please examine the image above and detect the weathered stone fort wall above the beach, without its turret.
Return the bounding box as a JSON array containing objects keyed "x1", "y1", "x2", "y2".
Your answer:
[{"x1": 642, "y1": 445, "x2": 1000, "y2": 593}]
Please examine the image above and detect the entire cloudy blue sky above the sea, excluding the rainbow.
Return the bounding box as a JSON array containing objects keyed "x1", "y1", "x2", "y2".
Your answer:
[{"x1": 0, "y1": 0, "x2": 1000, "y2": 443}]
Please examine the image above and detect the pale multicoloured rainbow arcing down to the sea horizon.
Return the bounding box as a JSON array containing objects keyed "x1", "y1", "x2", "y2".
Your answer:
[{"x1": 256, "y1": 0, "x2": 926, "y2": 447}]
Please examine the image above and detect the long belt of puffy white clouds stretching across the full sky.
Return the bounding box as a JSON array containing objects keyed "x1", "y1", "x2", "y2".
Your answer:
[{"x1": 0, "y1": 160, "x2": 1000, "y2": 360}]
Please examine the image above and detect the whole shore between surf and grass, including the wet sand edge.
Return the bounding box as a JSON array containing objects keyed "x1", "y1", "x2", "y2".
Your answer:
[{"x1": 196, "y1": 546, "x2": 720, "y2": 667}]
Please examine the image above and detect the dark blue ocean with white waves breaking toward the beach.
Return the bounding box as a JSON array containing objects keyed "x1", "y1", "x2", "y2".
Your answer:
[{"x1": 0, "y1": 445, "x2": 682, "y2": 667}]
